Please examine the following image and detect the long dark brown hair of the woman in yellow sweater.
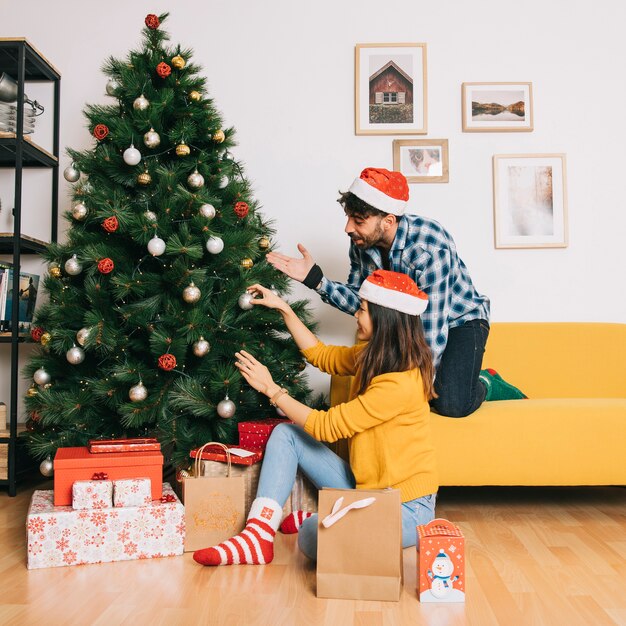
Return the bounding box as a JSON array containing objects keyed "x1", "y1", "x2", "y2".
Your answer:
[{"x1": 358, "y1": 302, "x2": 437, "y2": 400}]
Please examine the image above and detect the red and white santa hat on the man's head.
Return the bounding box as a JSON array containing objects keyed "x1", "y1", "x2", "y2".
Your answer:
[{"x1": 348, "y1": 167, "x2": 409, "y2": 215}]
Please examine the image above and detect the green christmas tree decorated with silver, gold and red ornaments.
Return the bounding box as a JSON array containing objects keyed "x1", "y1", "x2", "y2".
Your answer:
[{"x1": 25, "y1": 14, "x2": 312, "y2": 466}]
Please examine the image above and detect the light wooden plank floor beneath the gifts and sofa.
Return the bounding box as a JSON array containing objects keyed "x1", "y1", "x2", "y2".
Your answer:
[{"x1": 0, "y1": 482, "x2": 626, "y2": 626}]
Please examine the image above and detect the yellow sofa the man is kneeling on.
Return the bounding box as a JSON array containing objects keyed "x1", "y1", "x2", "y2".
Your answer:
[{"x1": 330, "y1": 322, "x2": 626, "y2": 486}]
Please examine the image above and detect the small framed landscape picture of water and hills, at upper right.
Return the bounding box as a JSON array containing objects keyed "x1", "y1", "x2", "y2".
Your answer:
[{"x1": 462, "y1": 83, "x2": 533, "y2": 133}]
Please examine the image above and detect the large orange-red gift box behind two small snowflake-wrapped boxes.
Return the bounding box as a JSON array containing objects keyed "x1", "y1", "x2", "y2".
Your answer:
[{"x1": 54, "y1": 446, "x2": 163, "y2": 506}]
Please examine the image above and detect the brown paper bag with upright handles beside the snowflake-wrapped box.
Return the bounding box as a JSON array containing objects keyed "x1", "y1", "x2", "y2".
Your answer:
[{"x1": 183, "y1": 442, "x2": 246, "y2": 552}]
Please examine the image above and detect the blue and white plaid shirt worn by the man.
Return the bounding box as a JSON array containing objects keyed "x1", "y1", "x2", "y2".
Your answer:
[{"x1": 317, "y1": 215, "x2": 489, "y2": 367}]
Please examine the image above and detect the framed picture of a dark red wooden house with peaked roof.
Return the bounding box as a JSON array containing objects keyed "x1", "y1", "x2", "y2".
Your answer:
[{"x1": 354, "y1": 43, "x2": 428, "y2": 135}]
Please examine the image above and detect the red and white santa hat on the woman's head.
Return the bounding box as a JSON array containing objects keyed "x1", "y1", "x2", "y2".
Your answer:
[{"x1": 359, "y1": 270, "x2": 428, "y2": 315}]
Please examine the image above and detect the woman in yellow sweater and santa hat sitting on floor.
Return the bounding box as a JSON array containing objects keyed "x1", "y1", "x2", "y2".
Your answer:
[{"x1": 194, "y1": 270, "x2": 438, "y2": 565}]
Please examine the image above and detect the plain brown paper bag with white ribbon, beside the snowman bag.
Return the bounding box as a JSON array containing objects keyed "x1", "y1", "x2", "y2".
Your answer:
[{"x1": 317, "y1": 489, "x2": 402, "y2": 602}]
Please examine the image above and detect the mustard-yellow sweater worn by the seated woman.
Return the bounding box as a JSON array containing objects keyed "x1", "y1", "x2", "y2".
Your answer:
[{"x1": 302, "y1": 342, "x2": 438, "y2": 502}]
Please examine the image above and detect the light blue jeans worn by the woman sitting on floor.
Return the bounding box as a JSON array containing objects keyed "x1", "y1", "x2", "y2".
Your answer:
[{"x1": 257, "y1": 424, "x2": 437, "y2": 560}]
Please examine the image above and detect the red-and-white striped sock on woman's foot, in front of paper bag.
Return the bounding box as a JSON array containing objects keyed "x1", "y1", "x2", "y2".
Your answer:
[{"x1": 193, "y1": 498, "x2": 282, "y2": 565}]
